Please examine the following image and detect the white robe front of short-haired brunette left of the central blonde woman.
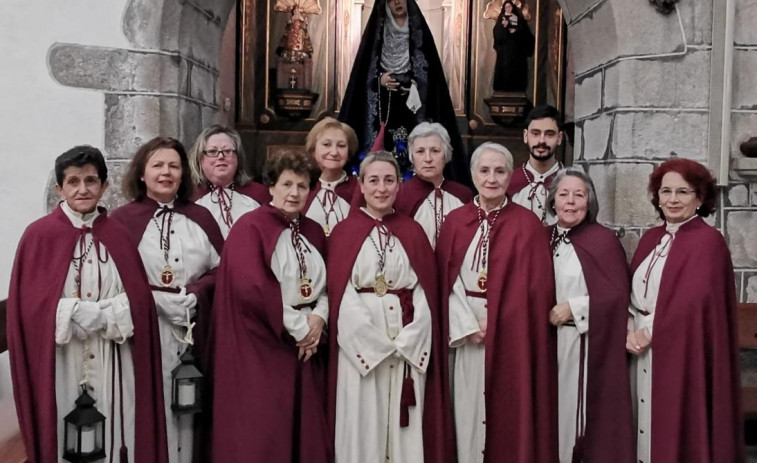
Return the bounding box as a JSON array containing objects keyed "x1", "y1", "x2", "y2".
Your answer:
[{"x1": 271, "y1": 228, "x2": 329, "y2": 342}]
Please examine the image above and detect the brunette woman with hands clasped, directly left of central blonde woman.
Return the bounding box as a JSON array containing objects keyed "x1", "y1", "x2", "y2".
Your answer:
[{"x1": 210, "y1": 153, "x2": 331, "y2": 463}]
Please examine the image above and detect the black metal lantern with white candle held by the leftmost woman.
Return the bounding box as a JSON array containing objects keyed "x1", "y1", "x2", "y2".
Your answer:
[{"x1": 63, "y1": 386, "x2": 105, "y2": 463}]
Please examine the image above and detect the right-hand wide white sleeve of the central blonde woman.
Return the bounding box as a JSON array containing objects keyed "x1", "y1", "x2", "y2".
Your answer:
[{"x1": 394, "y1": 285, "x2": 432, "y2": 373}]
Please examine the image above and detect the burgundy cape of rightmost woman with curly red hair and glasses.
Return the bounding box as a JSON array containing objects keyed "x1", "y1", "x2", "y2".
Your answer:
[{"x1": 631, "y1": 217, "x2": 745, "y2": 462}]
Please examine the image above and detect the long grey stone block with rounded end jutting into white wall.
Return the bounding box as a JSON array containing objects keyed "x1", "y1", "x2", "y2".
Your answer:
[{"x1": 48, "y1": 44, "x2": 178, "y2": 92}]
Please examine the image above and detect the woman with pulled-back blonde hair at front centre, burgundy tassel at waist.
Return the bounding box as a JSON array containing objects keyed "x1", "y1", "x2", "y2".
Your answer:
[{"x1": 328, "y1": 152, "x2": 448, "y2": 463}]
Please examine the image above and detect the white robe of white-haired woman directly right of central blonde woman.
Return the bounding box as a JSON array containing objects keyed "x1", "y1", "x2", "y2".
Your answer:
[{"x1": 449, "y1": 220, "x2": 489, "y2": 463}]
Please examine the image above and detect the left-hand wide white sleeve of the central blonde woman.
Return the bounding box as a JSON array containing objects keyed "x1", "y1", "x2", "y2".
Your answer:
[{"x1": 337, "y1": 282, "x2": 396, "y2": 376}]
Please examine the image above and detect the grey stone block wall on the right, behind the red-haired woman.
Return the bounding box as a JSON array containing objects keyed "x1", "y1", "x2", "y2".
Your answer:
[{"x1": 563, "y1": 0, "x2": 757, "y2": 302}]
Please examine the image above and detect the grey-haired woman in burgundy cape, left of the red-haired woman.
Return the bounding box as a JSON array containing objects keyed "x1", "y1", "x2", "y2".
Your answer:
[{"x1": 547, "y1": 167, "x2": 636, "y2": 463}]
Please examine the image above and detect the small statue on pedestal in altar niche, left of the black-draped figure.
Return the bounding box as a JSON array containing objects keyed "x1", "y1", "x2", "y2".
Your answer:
[{"x1": 273, "y1": 0, "x2": 322, "y2": 119}]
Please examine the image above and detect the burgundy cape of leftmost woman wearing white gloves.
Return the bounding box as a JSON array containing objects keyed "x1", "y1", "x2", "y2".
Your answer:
[{"x1": 8, "y1": 206, "x2": 168, "y2": 463}]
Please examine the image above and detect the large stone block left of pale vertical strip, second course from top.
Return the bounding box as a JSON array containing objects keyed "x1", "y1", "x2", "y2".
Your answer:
[{"x1": 604, "y1": 50, "x2": 710, "y2": 108}]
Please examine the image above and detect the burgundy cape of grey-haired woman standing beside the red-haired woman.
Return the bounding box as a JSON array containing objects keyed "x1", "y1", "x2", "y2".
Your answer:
[{"x1": 568, "y1": 223, "x2": 636, "y2": 463}]
